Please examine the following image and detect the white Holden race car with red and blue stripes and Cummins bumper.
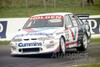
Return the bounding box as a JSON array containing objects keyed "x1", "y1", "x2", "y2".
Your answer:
[{"x1": 10, "y1": 12, "x2": 91, "y2": 56}]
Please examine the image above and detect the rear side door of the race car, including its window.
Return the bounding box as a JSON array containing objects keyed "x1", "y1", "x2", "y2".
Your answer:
[{"x1": 69, "y1": 14, "x2": 79, "y2": 47}]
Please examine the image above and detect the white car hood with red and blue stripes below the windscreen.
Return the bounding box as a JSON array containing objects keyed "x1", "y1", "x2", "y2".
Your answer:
[{"x1": 14, "y1": 27, "x2": 62, "y2": 38}]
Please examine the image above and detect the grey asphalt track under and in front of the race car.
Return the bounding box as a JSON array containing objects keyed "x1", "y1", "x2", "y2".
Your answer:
[{"x1": 0, "y1": 44, "x2": 100, "y2": 67}]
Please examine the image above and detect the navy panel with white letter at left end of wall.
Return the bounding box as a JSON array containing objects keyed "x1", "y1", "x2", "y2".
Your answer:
[{"x1": 0, "y1": 21, "x2": 7, "y2": 38}]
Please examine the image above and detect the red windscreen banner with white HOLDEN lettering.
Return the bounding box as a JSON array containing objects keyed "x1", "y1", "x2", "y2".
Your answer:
[{"x1": 28, "y1": 15, "x2": 63, "y2": 21}]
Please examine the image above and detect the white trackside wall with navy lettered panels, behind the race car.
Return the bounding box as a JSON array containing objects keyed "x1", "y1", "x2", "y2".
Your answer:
[{"x1": 0, "y1": 15, "x2": 100, "y2": 40}]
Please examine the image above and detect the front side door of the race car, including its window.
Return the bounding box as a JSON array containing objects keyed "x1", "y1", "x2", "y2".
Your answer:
[{"x1": 65, "y1": 15, "x2": 77, "y2": 47}]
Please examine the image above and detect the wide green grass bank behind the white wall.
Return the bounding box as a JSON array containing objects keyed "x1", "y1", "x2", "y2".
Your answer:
[{"x1": 0, "y1": 0, "x2": 100, "y2": 18}]
